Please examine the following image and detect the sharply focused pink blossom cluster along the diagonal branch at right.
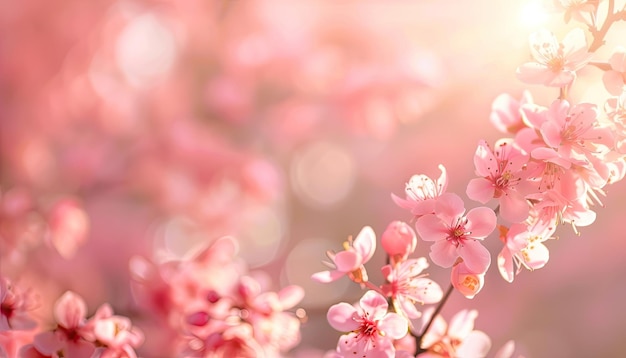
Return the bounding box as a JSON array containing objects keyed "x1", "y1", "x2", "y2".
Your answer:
[{"x1": 313, "y1": 0, "x2": 626, "y2": 357}]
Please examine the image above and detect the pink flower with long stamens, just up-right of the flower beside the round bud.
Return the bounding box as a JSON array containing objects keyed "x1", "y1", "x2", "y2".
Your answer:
[{"x1": 467, "y1": 138, "x2": 529, "y2": 222}]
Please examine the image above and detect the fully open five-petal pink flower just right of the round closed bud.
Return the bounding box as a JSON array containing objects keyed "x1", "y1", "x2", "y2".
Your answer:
[{"x1": 415, "y1": 193, "x2": 496, "y2": 272}]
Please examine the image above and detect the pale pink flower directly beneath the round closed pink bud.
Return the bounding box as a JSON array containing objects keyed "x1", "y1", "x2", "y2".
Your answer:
[{"x1": 381, "y1": 257, "x2": 443, "y2": 319}]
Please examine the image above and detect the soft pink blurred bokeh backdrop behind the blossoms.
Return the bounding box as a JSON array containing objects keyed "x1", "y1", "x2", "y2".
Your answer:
[{"x1": 0, "y1": 0, "x2": 626, "y2": 357}]
